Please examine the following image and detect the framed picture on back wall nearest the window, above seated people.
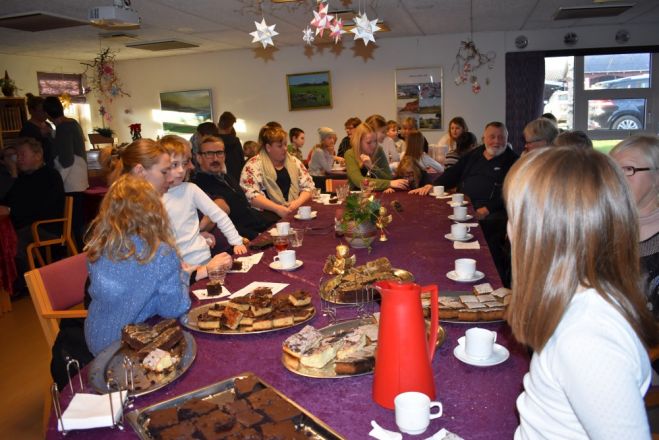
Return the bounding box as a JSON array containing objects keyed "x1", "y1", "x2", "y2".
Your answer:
[{"x1": 396, "y1": 67, "x2": 443, "y2": 131}]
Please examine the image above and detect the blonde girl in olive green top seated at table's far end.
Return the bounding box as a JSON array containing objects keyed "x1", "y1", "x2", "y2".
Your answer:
[{"x1": 345, "y1": 123, "x2": 407, "y2": 191}]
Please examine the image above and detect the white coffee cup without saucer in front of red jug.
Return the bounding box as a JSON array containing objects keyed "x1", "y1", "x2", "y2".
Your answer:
[{"x1": 394, "y1": 391, "x2": 443, "y2": 435}]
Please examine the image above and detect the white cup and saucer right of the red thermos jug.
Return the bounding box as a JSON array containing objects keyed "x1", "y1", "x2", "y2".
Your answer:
[{"x1": 453, "y1": 327, "x2": 510, "y2": 367}]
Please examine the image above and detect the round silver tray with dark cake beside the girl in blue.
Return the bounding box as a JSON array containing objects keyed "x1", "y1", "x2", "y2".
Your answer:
[{"x1": 89, "y1": 319, "x2": 197, "y2": 396}]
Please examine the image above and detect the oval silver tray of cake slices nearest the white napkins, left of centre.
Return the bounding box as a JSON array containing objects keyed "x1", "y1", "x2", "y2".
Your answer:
[{"x1": 181, "y1": 287, "x2": 316, "y2": 335}]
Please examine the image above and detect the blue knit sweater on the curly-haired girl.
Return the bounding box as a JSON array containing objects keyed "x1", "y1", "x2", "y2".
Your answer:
[{"x1": 85, "y1": 240, "x2": 190, "y2": 356}]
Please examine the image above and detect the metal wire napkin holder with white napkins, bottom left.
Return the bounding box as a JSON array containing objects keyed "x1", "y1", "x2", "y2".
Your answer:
[{"x1": 50, "y1": 358, "x2": 134, "y2": 435}]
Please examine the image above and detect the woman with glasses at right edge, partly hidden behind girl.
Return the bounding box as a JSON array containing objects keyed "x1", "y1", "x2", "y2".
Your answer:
[{"x1": 609, "y1": 135, "x2": 659, "y2": 320}]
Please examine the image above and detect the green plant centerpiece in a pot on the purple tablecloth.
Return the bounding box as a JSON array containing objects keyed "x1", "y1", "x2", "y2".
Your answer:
[{"x1": 340, "y1": 193, "x2": 381, "y2": 248}]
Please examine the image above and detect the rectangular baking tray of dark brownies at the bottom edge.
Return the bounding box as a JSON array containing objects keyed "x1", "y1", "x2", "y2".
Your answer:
[{"x1": 126, "y1": 373, "x2": 342, "y2": 440}]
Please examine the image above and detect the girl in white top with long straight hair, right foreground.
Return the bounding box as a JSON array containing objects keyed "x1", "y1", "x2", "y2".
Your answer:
[{"x1": 504, "y1": 147, "x2": 659, "y2": 439}]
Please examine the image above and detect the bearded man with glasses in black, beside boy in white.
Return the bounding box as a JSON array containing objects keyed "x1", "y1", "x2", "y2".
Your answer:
[{"x1": 193, "y1": 136, "x2": 279, "y2": 239}]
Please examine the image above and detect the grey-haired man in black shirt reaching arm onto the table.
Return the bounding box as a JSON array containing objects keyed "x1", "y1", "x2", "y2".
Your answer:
[{"x1": 434, "y1": 122, "x2": 518, "y2": 285}]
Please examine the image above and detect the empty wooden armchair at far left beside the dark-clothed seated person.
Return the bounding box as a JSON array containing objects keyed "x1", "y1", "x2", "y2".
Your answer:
[{"x1": 27, "y1": 197, "x2": 78, "y2": 269}]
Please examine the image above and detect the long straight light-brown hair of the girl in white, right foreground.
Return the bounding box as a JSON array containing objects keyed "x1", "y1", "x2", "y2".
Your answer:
[{"x1": 503, "y1": 147, "x2": 659, "y2": 351}]
